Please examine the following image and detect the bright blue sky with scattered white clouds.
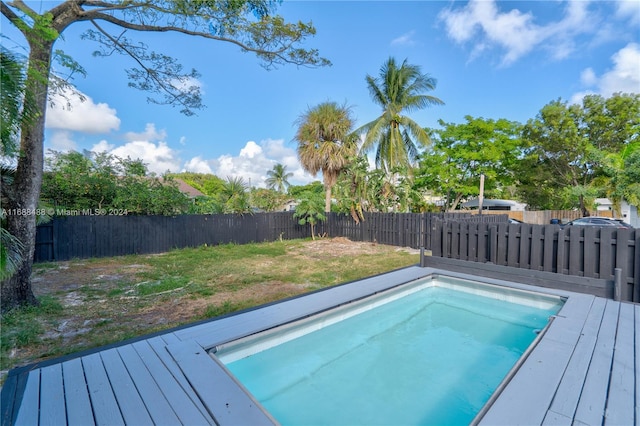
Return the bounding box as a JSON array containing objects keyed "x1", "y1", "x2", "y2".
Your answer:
[{"x1": 2, "y1": 0, "x2": 640, "y2": 186}]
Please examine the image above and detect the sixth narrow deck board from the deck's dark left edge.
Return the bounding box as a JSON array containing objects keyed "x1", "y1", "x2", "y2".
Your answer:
[{"x1": 118, "y1": 345, "x2": 180, "y2": 425}]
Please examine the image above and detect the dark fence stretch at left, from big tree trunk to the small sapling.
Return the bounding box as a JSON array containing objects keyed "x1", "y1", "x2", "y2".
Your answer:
[{"x1": 35, "y1": 212, "x2": 310, "y2": 262}]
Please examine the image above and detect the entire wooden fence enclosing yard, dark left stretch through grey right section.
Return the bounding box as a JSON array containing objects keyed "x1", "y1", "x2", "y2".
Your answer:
[{"x1": 35, "y1": 212, "x2": 640, "y2": 302}]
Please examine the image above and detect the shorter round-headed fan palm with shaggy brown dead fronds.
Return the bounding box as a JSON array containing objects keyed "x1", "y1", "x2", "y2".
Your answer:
[{"x1": 295, "y1": 102, "x2": 357, "y2": 212}]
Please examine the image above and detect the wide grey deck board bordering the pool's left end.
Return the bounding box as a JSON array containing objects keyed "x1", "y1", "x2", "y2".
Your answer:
[{"x1": 167, "y1": 341, "x2": 275, "y2": 426}]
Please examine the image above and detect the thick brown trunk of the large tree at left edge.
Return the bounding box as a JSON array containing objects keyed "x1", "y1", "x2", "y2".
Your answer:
[{"x1": 0, "y1": 38, "x2": 53, "y2": 312}]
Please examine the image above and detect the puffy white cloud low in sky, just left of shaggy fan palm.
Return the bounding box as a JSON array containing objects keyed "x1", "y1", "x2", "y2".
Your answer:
[{"x1": 207, "y1": 139, "x2": 314, "y2": 187}]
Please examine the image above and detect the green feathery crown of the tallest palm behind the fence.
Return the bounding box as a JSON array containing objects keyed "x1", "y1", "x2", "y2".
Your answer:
[{"x1": 355, "y1": 58, "x2": 444, "y2": 170}]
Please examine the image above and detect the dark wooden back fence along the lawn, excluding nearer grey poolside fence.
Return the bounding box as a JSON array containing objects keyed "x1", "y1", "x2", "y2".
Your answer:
[{"x1": 35, "y1": 212, "x2": 506, "y2": 262}]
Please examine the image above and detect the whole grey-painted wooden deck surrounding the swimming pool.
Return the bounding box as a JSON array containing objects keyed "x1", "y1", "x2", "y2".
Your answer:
[{"x1": 1, "y1": 267, "x2": 640, "y2": 425}]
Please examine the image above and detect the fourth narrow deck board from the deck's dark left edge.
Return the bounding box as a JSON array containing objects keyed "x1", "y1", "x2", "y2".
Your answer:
[{"x1": 82, "y1": 353, "x2": 124, "y2": 425}]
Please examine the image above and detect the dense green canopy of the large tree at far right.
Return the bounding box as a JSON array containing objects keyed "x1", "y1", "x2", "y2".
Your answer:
[{"x1": 517, "y1": 94, "x2": 640, "y2": 216}]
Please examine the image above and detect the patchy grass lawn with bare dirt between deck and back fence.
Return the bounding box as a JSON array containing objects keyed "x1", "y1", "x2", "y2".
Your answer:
[{"x1": 0, "y1": 238, "x2": 418, "y2": 378}]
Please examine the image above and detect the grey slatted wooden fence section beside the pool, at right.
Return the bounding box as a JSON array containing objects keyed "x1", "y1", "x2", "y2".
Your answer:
[{"x1": 426, "y1": 220, "x2": 640, "y2": 302}]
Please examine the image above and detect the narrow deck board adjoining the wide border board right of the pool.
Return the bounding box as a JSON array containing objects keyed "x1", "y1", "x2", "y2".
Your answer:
[{"x1": 551, "y1": 298, "x2": 606, "y2": 418}]
